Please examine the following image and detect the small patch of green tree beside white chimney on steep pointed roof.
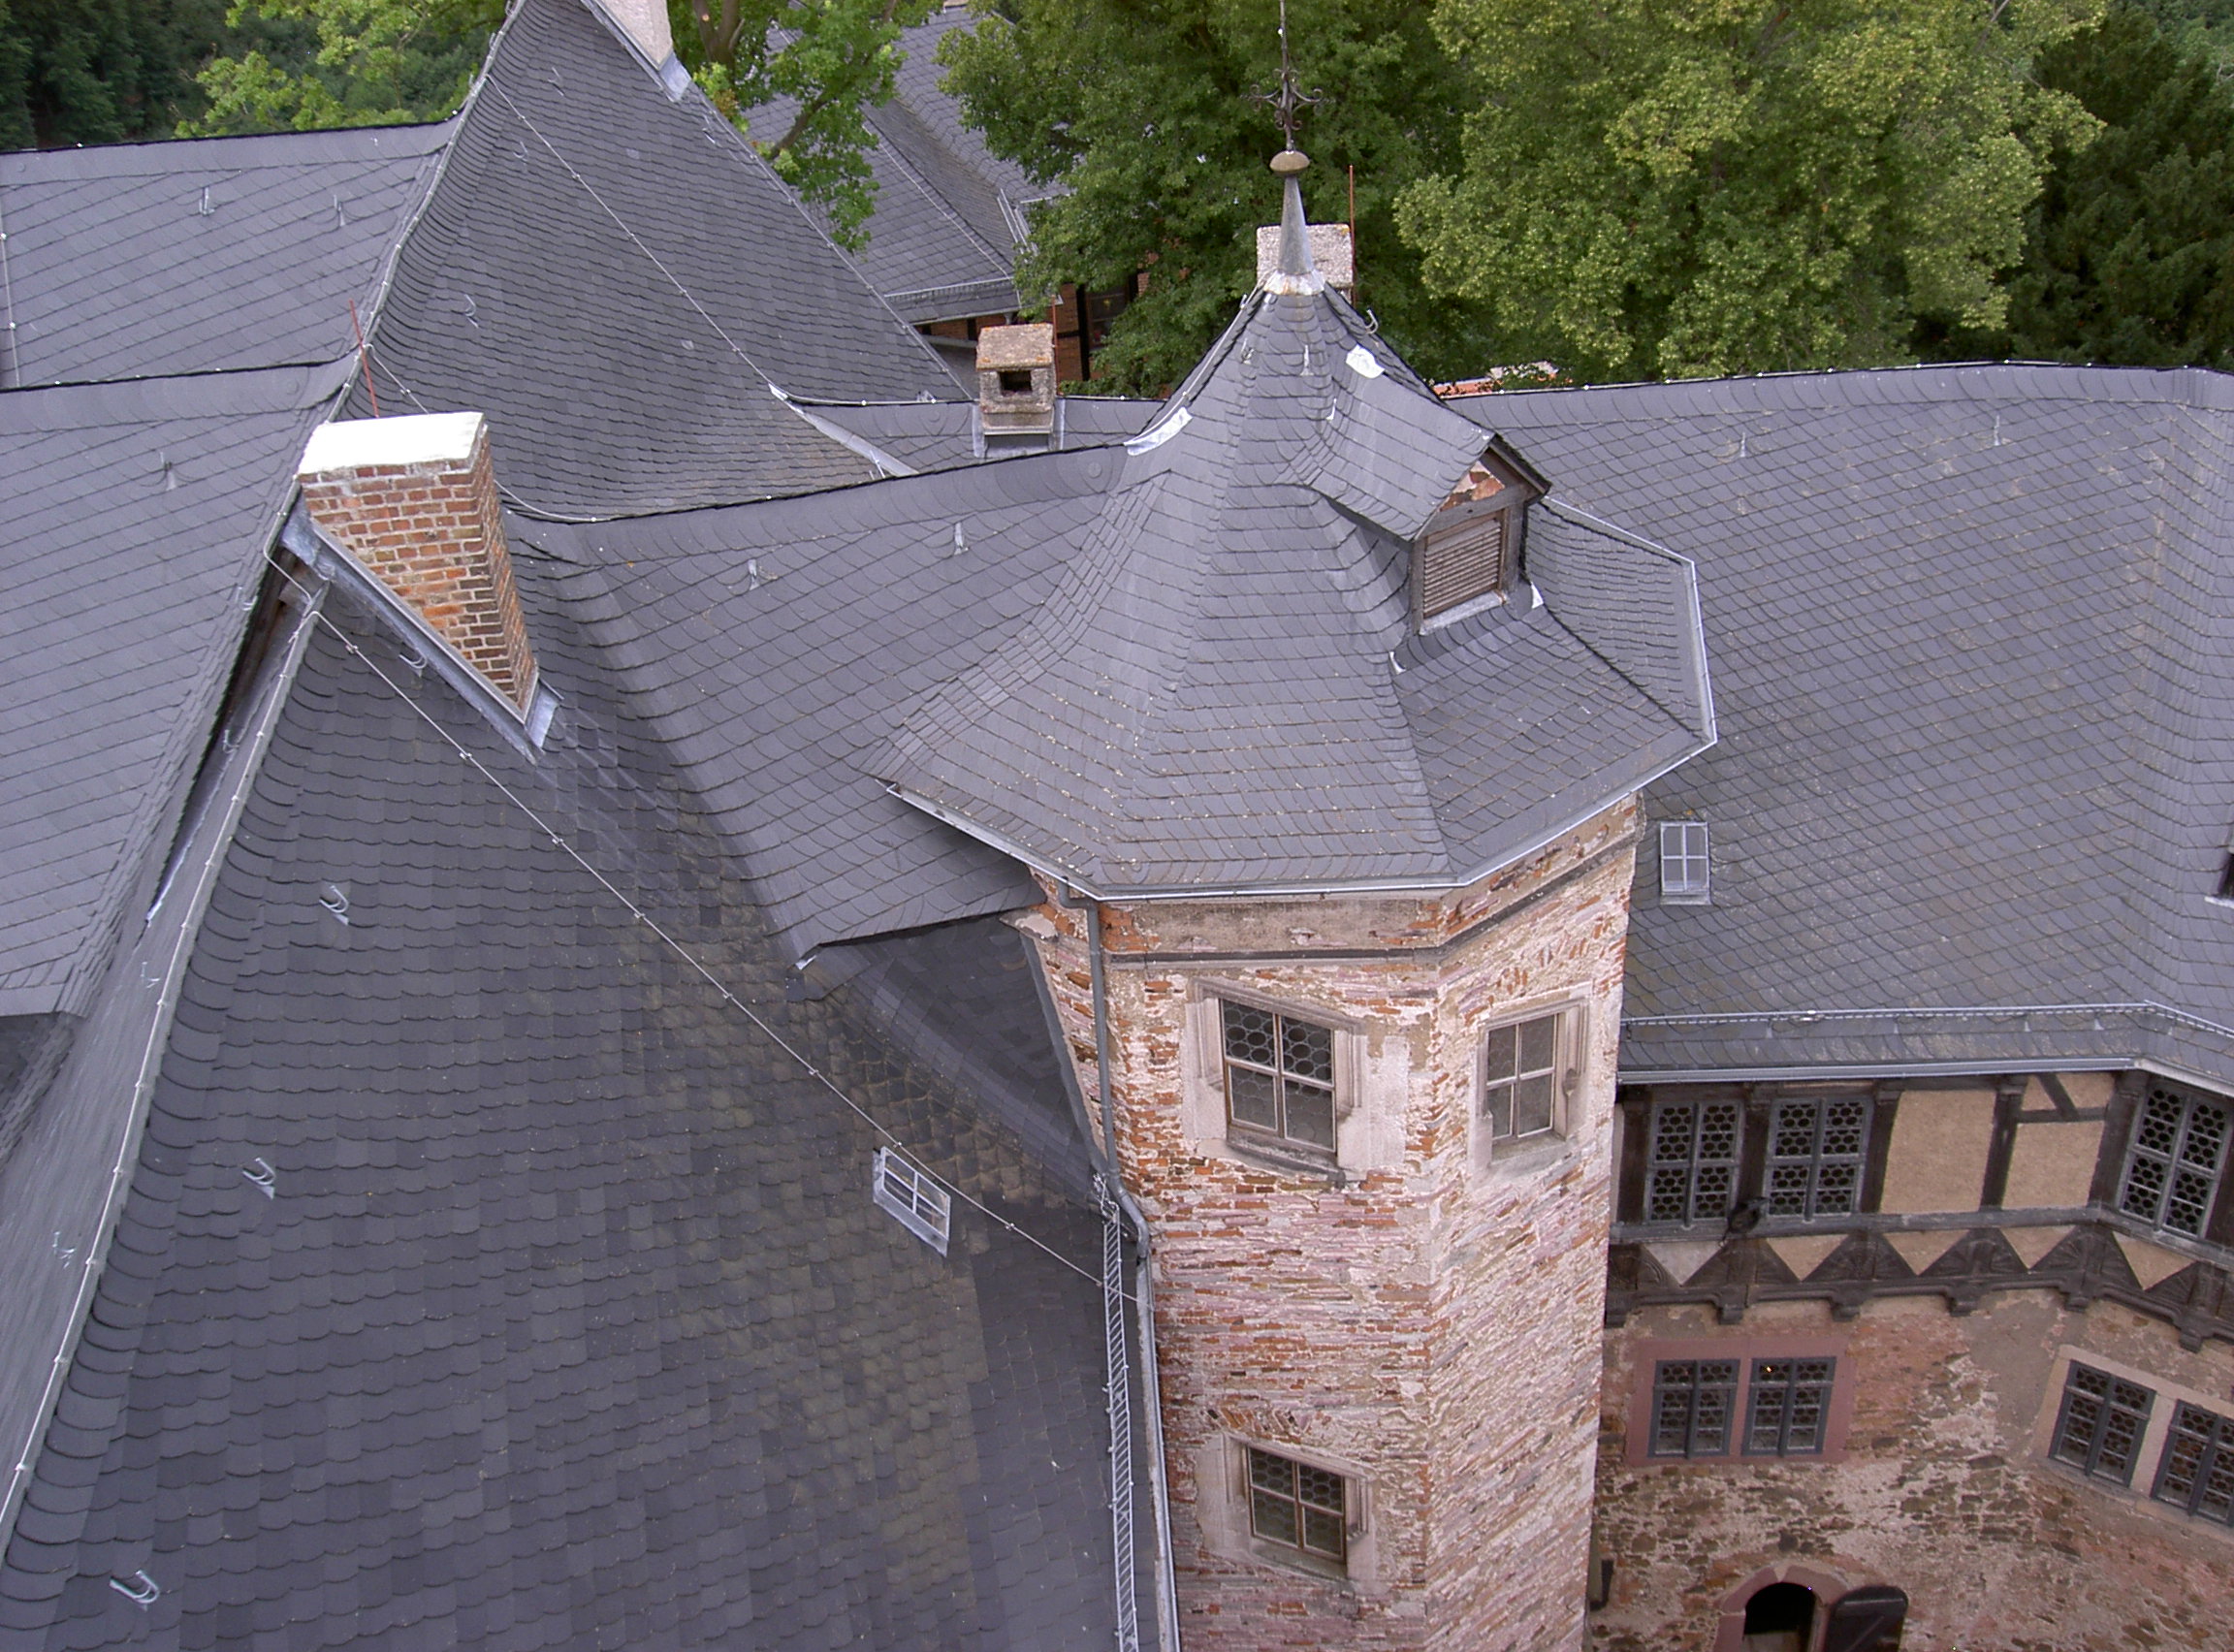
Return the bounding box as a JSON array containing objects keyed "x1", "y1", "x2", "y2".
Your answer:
[{"x1": 668, "y1": 0, "x2": 939, "y2": 248}]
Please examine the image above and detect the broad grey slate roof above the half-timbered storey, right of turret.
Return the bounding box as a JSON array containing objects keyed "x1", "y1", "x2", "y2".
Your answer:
[{"x1": 1461, "y1": 366, "x2": 2234, "y2": 1085}]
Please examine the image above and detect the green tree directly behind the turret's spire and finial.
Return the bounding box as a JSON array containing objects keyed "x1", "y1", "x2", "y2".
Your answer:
[{"x1": 941, "y1": 0, "x2": 1485, "y2": 391}]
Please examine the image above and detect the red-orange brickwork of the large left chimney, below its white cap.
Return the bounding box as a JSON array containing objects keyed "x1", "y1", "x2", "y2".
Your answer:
[{"x1": 302, "y1": 425, "x2": 536, "y2": 710}]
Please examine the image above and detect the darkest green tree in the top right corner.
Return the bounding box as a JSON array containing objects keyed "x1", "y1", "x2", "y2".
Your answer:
[{"x1": 1924, "y1": 5, "x2": 2234, "y2": 366}]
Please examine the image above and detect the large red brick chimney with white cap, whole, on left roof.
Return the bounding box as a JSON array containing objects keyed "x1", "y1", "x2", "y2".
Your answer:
[{"x1": 295, "y1": 413, "x2": 536, "y2": 716}]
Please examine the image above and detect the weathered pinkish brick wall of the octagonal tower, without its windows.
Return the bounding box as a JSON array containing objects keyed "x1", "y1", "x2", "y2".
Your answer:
[{"x1": 1028, "y1": 806, "x2": 1636, "y2": 1652}]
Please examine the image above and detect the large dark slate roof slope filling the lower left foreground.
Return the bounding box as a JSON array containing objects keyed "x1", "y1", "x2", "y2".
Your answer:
[{"x1": 0, "y1": 576, "x2": 1115, "y2": 1652}]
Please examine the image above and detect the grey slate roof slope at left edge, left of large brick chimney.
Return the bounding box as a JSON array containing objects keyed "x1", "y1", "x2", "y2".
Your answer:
[{"x1": 0, "y1": 366, "x2": 346, "y2": 1016}]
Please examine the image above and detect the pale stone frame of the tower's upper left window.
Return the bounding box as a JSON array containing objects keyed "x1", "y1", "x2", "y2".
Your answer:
[{"x1": 1180, "y1": 975, "x2": 1403, "y2": 1188}]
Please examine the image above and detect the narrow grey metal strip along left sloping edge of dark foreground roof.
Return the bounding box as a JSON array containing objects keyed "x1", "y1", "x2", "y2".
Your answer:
[{"x1": 0, "y1": 588, "x2": 324, "y2": 1542}]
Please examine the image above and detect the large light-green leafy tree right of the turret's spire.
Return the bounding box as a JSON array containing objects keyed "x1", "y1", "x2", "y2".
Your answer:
[{"x1": 1401, "y1": 0, "x2": 2100, "y2": 377}]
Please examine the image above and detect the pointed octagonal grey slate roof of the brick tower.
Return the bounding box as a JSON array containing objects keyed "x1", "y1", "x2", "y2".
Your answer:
[{"x1": 878, "y1": 293, "x2": 1711, "y2": 893}]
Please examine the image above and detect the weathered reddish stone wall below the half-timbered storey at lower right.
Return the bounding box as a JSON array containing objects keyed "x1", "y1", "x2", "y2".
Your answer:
[{"x1": 1590, "y1": 1290, "x2": 2234, "y2": 1652}]
